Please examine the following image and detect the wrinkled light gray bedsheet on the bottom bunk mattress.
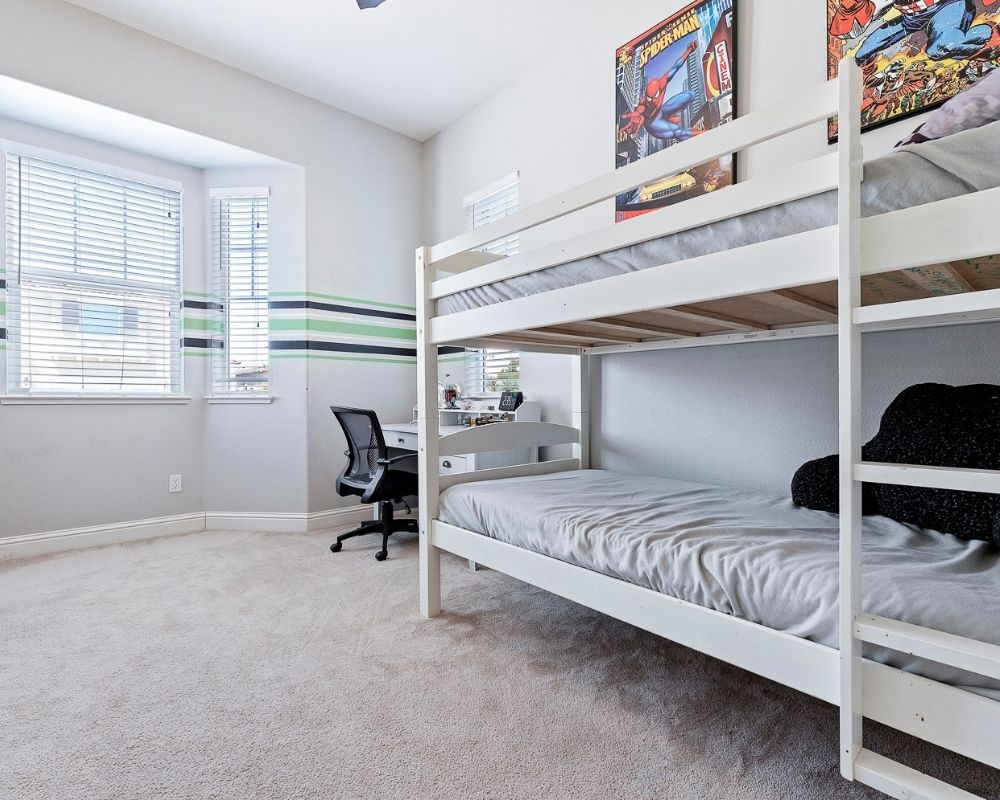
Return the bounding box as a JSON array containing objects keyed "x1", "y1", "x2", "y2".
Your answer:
[{"x1": 439, "y1": 470, "x2": 1000, "y2": 699}]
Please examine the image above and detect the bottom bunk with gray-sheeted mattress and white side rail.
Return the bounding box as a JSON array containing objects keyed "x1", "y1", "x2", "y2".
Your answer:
[{"x1": 431, "y1": 470, "x2": 1000, "y2": 767}]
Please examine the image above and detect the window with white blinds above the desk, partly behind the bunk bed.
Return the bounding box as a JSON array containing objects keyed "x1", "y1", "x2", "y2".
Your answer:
[{"x1": 463, "y1": 173, "x2": 521, "y2": 395}]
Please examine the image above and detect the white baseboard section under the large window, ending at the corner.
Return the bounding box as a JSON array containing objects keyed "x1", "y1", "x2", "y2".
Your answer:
[{"x1": 0, "y1": 512, "x2": 205, "y2": 561}]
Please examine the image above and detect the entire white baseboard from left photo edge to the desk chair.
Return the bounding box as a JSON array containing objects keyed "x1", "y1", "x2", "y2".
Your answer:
[{"x1": 0, "y1": 505, "x2": 377, "y2": 562}]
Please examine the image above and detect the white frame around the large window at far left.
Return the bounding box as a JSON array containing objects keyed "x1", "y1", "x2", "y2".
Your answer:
[{"x1": 0, "y1": 138, "x2": 185, "y2": 405}]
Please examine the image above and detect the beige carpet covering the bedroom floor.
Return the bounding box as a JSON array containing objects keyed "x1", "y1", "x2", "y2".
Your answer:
[{"x1": 0, "y1": 533, "x2": 1000, "y2": 800}]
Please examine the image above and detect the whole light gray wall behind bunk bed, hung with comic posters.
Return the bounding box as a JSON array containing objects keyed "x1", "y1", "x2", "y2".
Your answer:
[{"x1": 425, "y1": 0, "x2": 1000, "y2": 491}]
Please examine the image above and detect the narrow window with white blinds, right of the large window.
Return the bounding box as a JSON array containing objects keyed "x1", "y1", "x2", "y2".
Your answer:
[{"x1": 212, "y1": 188, "x2": 270, "y2": 394}]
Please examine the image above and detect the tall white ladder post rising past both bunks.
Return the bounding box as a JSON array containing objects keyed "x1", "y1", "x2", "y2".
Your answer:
[{"x1": 837, "y1": 58, "x2": 864, "y2": 780}]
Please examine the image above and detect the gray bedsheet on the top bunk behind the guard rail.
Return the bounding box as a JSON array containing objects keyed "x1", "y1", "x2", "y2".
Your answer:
[{"x1": 438, "y1": 122, "x2": 1000, "y2": 314}]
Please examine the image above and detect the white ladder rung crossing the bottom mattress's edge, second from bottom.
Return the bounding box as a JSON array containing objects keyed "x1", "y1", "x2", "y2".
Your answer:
[{"x1": 854, "y1": 614, "x2": 1000, "y2": 680}]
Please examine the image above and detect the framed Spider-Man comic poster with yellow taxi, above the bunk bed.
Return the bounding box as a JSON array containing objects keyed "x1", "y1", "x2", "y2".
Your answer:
[{"x1": 615, "y1": 0, "x2": 736, "y2": 222}]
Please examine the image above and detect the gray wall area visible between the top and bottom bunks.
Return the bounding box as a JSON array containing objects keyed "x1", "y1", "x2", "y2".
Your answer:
[{"x1": 592, "y1": 324, "x2": 1000, "y2": 492}]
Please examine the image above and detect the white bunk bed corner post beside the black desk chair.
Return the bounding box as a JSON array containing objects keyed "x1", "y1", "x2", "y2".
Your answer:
[{"x1": 416, "y1": 247, "x2": 441, "y2": 617}]
